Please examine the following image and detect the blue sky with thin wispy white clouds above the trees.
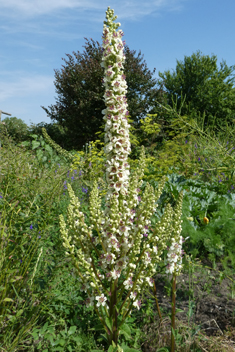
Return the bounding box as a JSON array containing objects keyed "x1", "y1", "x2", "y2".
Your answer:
[{"x1": 0, "y1": 0, "x2": 235, "y2": 125}]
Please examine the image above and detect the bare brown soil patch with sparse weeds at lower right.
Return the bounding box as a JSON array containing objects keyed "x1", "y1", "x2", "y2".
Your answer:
[{"x1": 140, "y1": 263, "x2": 235, "y2": 352}]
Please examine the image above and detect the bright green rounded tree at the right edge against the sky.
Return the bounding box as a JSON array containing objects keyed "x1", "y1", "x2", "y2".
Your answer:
[{"x1": 158, "y1": 51, "x2": 235, "y2": 127}]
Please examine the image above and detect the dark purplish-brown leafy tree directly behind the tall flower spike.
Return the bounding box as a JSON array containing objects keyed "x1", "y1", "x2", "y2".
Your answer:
[{"x1": 42, "y1": 38, "x2": 158, "y2": 149}]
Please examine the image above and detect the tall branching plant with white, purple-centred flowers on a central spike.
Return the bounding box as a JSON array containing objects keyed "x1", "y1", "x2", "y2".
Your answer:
[{"x1": 60, "y1": 8, "x2": 182, "y2": 346}]
